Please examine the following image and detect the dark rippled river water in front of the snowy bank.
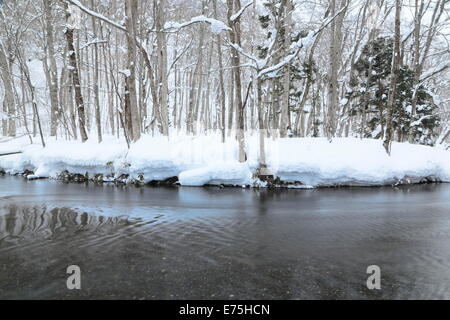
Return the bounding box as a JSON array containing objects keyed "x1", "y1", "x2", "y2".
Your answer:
[{"x1": 0, "y1": 177, "x2": 450, "y2": 299}]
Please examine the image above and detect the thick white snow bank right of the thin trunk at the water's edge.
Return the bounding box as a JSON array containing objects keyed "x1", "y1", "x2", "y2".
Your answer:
[{"x1": 272, "y1": 138, "x2": 450, "y2": 186}]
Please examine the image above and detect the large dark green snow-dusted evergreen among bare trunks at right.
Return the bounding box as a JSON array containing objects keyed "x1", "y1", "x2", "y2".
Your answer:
[{"x1": 347, "y1": 37, "x2": 440, "y2": 145}]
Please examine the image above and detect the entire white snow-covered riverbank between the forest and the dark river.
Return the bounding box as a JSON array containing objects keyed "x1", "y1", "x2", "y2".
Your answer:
[{"x1": 0, "y1": 136, "x2": 450, "y2": 187}]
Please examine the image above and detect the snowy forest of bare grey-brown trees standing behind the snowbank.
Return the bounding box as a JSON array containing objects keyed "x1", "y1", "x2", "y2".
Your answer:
[{"x1": 0, "y1": 0, "x2": 450, "y2": 188}]
